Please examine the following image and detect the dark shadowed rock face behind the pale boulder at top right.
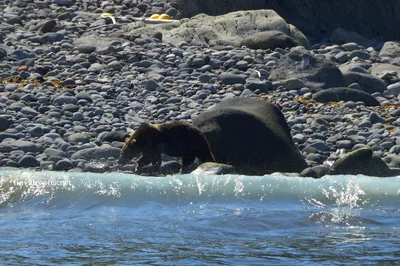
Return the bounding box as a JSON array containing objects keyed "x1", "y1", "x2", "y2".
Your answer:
[{"x1": 177, "y1": 0, "x2": 400, "y2": 40}]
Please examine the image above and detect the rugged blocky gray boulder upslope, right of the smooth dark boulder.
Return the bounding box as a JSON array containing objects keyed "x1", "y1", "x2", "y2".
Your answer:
[{"x1": 269, "y1": 48, "x2": 345, "y2": 90}]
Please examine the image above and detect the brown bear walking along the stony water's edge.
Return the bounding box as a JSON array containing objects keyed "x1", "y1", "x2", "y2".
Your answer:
[{"x1": 118, "y1": 121, "x2": 215, "y2": 171}]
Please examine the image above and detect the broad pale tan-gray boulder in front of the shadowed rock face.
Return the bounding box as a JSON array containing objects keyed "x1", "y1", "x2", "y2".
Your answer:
[{"x1": 122, "y1": 10, "x2": 310, "y2": 48}]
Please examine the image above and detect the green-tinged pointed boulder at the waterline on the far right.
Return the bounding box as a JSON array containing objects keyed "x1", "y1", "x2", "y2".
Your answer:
[{"x1": 330, "y1": 147, "x2": 396, "y2": 177}]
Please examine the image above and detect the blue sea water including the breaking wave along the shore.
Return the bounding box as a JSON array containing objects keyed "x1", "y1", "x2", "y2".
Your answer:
[{"x1": 0, "y1": 170, "x2": 400, "y2": 265}]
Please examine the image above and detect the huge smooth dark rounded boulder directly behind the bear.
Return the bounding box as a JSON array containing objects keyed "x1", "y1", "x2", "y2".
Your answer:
[{"x1": 193, "y1": 98, "x2": 307, "y2": 175}]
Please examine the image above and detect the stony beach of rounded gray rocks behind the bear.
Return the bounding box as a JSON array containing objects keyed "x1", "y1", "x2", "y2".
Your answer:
[{"x1": 0, "y1": 0, "x2": 400, "y2": 177}]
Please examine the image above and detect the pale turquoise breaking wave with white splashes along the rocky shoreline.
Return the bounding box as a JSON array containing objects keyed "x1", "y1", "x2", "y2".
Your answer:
[{"x1": 0, "y1": 171, "x2": 400, "y2": 208}]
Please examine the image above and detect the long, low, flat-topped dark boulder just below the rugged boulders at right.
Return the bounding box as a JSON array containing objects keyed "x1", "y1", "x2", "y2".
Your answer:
[{"x1": 313, "y1": 88, "x2": 380, "y2": 106}]
